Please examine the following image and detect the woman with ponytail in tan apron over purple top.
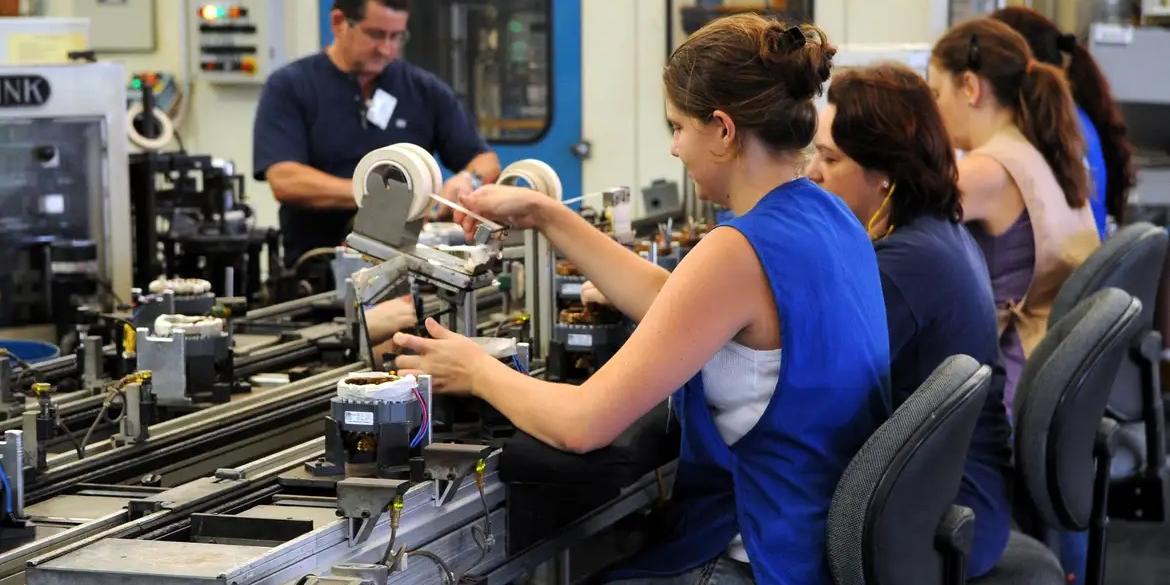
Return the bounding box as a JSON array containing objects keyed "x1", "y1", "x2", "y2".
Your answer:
[{"x1": 929, "y1": 19, "x2": 1100, "y2": 412}]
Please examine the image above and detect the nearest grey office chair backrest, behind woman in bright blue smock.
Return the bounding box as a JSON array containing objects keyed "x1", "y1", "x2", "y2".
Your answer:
[{"x1": 827, "y1": 356, "x2": 991, "y2": 585}]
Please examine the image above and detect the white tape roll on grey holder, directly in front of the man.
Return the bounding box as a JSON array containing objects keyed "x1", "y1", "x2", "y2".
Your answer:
[{"x1": 352, "y1": 143, "x2": 442, "y2": 221}]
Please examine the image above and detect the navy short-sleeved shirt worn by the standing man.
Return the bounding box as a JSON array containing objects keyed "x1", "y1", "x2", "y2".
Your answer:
[{"x1": 252, "y1": 53, "x2": 488, "y2": 263}]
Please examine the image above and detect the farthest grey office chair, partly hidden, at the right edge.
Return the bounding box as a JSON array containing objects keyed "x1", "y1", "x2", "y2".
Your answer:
[{"x1": 1048, "y1": 222, "x2": 1170, "y2": 522}]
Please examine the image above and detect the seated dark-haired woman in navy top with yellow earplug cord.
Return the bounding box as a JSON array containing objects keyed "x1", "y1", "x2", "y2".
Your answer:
[{"x1": 808, "y1": 64, "x2": 1011, "y2": 577}]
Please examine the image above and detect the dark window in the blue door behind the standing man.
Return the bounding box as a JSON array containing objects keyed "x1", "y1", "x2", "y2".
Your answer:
[{"x1": 406, "y1": 0, "x2": 552, "y2": 144}]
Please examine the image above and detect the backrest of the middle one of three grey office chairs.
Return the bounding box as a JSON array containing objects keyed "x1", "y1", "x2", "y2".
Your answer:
[{"x1": 1014, "y1": 288, "x2": 1142, "y2": 530}]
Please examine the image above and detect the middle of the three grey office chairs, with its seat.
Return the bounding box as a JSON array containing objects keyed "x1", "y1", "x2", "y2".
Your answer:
[{"x1": 972, "y1": 288, "x2": 1142, "y2": 585}]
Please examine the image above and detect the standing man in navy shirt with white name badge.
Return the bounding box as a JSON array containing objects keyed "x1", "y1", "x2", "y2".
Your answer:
[{"x1": 253, "y1": 0, "x2": 500, "y2": 264}]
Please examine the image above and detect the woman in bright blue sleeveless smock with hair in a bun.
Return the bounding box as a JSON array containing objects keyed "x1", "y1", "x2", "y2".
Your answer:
[{"x1": 394, "y1": 15, "x2": 889, "y2": 585}]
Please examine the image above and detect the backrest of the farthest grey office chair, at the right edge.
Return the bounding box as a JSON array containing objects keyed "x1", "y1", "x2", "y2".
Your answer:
[{"x1": 1048, "y1": 222, "x2": 1170, "y2": 421}]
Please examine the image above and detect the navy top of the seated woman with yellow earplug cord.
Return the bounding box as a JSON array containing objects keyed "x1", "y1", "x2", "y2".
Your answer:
[{"x1": 874, "y1": 216, "x2": 1012, "y2": 577}]
